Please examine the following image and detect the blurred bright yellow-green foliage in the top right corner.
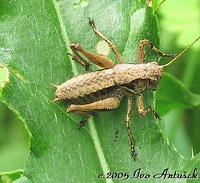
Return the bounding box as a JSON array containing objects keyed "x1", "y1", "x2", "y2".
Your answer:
[{"x1": 160, "y1": 0, "x2": 200, "y2": 45}]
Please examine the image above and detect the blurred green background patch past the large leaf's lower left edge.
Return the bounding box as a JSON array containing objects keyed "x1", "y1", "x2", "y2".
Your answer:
[{"x1": 0, "y1": 102, "x2": 29, "y2": 172}]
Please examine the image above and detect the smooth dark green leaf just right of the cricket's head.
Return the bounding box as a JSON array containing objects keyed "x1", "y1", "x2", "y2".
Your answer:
[{"x1": 156, "y1": 73, "x2": 200, "y2": 115}]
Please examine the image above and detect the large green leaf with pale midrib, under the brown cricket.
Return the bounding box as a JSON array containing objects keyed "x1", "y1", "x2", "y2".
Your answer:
[{"x1": 0, "y1": 0, "x2": 200, "y2": 182}]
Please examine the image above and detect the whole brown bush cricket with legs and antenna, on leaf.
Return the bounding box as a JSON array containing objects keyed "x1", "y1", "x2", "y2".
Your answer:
[{"x1": 51, "y1": 18, "x2": 200, "y2": 159}]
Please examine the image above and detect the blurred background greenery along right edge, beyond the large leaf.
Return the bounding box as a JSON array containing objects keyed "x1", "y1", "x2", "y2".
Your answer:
[{"x1": 157, "y1": 0, "x2": 200, "y2": 158}]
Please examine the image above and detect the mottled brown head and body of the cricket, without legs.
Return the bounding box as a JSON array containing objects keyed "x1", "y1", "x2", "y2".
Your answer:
[{"x1": 56, "y1": 62, "x2": 163, "y2": 104}]
